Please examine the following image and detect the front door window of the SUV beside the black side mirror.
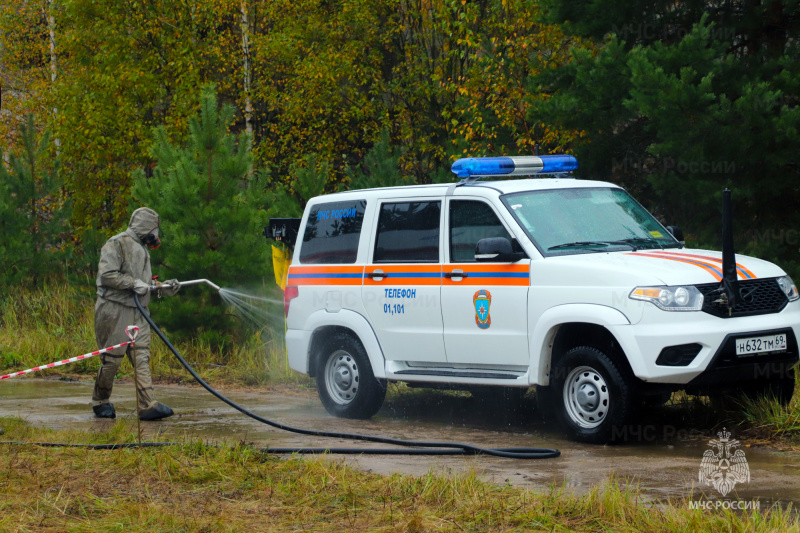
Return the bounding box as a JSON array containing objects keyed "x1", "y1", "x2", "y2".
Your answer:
[{"x1": 450, "y1": 200, "x2": 513, "y2": 263}]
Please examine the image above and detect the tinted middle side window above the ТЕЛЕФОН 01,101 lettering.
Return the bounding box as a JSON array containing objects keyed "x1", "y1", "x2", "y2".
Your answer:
[{"x1": 374, "y1": 202, "x2": 442, "y2": 263}]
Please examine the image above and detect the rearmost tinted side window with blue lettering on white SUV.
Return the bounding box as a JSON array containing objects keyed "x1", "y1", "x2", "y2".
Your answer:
[{"x1": 300, "y1": 200, "x2": 367, "y2": 264}]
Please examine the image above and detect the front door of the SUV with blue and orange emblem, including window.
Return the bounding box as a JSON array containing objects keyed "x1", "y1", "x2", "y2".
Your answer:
[{"x1": 442, "y1": 198, "x2": 530, "y2": 366}]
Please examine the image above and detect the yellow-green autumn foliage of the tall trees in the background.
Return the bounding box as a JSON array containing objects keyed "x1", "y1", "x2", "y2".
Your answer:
[{"x1": 0, "y1": 0, "x2": 575, "y2": 237}]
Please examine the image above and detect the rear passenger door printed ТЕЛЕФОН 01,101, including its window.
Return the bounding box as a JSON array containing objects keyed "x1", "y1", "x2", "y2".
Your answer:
[{"x1": 362, "y1": 198, "x2": 446, "y2": 362}]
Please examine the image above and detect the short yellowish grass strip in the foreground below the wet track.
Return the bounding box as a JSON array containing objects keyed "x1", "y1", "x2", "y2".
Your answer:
[{"x1": 0, "y1": 418, "x2": 800, "y2": 532}]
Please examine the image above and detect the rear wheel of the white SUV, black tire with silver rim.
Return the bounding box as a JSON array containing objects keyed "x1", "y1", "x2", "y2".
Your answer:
[{"x1": 317, "y1": 333, "x2": 386, "y2": 419}]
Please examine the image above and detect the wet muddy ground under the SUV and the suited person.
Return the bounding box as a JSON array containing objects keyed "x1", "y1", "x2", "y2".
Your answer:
[{"x1": 0, "y1": 379, "x2": 800, "y2": 509}]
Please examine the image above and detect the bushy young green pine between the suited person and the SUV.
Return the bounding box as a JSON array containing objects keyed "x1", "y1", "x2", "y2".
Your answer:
[{"x1": 133, "y1": 86, "x2": 272, "y2": 346}]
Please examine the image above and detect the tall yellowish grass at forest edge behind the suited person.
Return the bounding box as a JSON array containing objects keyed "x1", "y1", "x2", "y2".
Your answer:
[{"x1": 0, "y1": 283, "x2": 310, "y2": 386}]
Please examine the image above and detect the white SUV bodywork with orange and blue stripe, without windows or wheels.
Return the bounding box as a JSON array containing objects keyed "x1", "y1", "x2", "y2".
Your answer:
[{"x1": 286, "y1": 170, "x2": 800, "y2": 440}]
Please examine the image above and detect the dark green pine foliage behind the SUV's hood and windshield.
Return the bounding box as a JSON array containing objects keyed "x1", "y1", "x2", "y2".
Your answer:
[{"x1": 531, "y1": 0, "x2": 800, "y2": 274}]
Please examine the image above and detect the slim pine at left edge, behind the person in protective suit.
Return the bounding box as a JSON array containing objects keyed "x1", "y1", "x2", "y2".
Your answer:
[{"x1": 0, "y1": 115, "x2": 70, "y2": 286}]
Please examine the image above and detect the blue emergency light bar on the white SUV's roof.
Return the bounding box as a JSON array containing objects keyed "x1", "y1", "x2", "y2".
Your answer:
[{"x1": 450, "y1": 155, "x2": 578, "y2": 178}]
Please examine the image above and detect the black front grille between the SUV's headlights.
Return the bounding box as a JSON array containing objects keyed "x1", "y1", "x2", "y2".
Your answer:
[{"x1": 695, "y1": 278, "x2": 789, "y2": 318}]
